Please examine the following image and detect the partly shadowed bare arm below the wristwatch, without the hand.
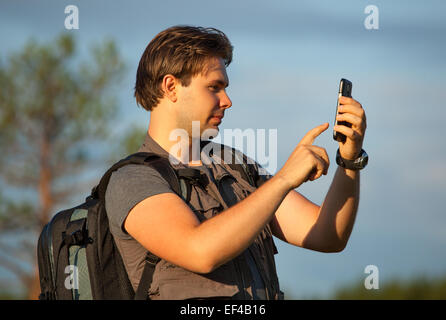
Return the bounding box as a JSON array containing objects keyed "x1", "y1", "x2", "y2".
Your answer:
[{"x1": 271, "y1": 167, "x2": 359, "y2": 252}]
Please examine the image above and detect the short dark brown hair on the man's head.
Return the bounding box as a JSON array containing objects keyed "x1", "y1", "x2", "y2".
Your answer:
[{"x1": 135, "y1": 25, "x2": 233, "y2": 111}]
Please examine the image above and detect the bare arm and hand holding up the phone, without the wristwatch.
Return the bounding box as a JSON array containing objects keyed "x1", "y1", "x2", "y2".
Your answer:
[{"x1": 271, "y1": 97, "x2": 367, "y2": 252}]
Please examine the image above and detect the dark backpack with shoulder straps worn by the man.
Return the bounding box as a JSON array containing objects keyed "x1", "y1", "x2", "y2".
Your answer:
[{"x1": 37, "y1": 148, "x2": 262, "y2": 300}]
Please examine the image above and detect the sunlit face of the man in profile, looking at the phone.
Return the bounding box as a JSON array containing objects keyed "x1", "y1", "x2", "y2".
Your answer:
[{"x1": 177, "y1": 58, "x2": 232, "y2": 137}]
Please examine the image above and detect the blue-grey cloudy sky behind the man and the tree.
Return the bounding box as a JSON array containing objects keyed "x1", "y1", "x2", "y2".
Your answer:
[{"x1": 0, "y1": 0, "x2": 446, "y2": 299}]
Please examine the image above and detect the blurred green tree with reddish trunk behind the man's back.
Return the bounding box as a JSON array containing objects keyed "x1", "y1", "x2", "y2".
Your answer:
[{"x1": 0, "y1": 33, "x2": 124, "y2": 295}]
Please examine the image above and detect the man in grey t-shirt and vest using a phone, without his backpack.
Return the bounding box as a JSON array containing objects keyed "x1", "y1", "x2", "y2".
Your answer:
[{"x1": 106, "y1": 26, "x2": 366, "y2": 299}]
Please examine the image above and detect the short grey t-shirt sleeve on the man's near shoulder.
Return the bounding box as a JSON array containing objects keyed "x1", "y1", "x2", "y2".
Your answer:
[{"x1": 105, "y1": 165, "x2": 175, "y2": 239}]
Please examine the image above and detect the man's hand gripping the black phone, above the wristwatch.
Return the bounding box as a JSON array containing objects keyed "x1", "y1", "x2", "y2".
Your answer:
[{"x1": 333, "y1": 96, "x2": 367, "y2": 160}]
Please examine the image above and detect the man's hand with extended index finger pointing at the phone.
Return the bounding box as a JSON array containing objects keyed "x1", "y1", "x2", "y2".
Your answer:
[{"x1": 276, "y1": 123, "x2": 330, "y2": 190}]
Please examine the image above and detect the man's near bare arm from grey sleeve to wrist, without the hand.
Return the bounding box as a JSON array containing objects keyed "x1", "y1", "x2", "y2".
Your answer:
[{"x1": 124, "y1": 172, "x2": 289, "y2": 273}]
